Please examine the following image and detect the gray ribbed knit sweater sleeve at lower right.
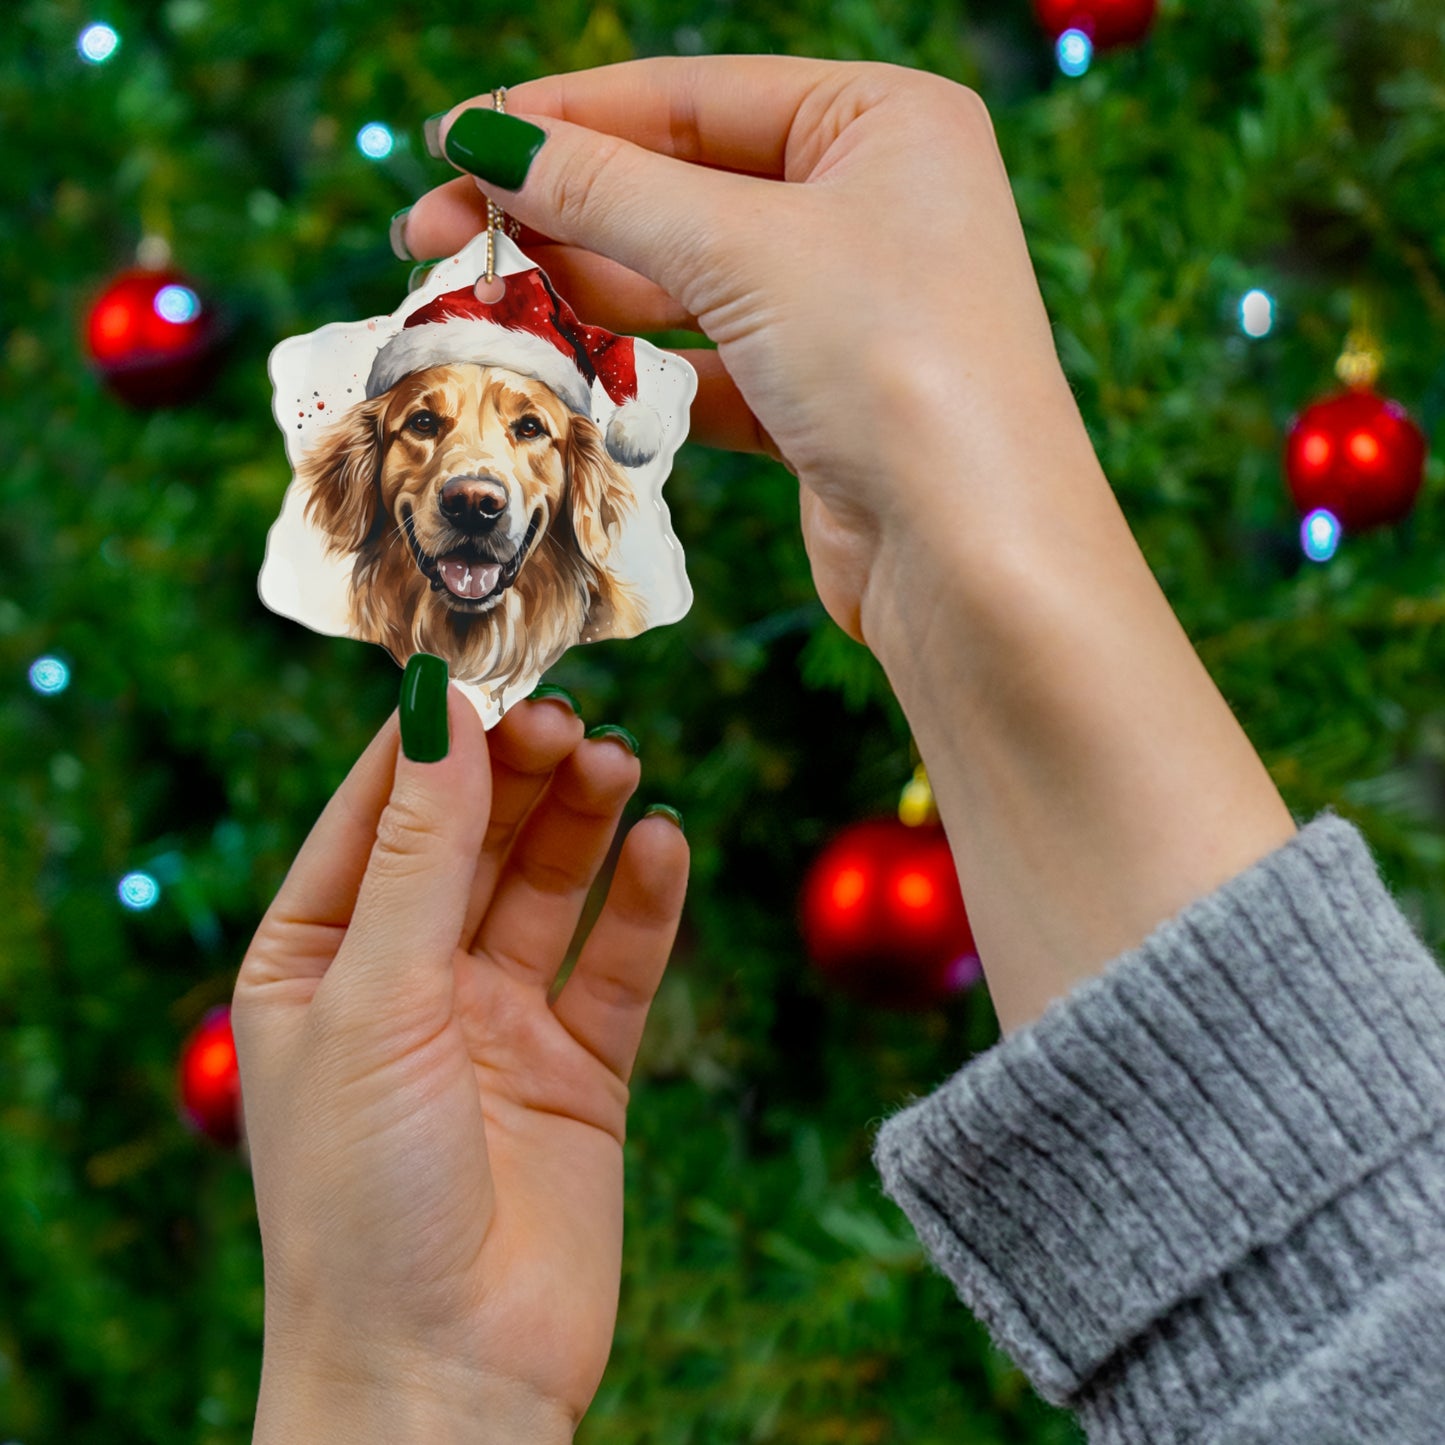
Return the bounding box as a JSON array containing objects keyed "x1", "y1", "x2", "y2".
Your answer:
[{"x1": 874, "y1": 812, "x2": 1445, "y2": 1445}]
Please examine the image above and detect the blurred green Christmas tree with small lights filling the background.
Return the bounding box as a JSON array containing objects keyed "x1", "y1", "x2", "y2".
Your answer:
[{"x1": 0, "y1": 0, "x2": 1445, "y2": 1445}]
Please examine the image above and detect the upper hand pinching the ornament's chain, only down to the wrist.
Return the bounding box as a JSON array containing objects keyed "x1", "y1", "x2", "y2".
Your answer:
[{"x1": 405, "y1": 56, "x2": 1101, "y2": 647}]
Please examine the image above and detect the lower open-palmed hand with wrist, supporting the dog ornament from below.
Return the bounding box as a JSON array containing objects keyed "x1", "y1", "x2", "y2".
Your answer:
[{"x1": 231, "y1": 689, "x2": 688, "y2": 1445}]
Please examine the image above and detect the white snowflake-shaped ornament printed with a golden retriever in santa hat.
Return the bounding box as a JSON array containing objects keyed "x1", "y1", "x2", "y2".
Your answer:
[{"x1": 260, "y1": 231, "x2": 696, "y2": 727}]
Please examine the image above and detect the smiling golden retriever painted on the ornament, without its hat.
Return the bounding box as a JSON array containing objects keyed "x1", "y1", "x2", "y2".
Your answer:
[{"x1": 298, "y1": 361, "x2": 647, "y2": 691}]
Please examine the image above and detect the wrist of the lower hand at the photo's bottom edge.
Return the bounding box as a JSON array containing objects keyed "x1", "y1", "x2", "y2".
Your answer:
[{"x1": 251, "y1": 1348, "x2": 577, "y2": 1445}]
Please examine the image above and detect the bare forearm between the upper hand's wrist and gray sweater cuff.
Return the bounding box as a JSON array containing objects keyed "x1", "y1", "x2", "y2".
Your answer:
[{"x1": 863, "y1": 390, "x2": 1295, "y2": 1032}]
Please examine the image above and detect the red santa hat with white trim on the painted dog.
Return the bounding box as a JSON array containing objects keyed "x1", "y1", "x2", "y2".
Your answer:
[{"x1": 366, "y1": 267, "x2": 662, "y2": 467}]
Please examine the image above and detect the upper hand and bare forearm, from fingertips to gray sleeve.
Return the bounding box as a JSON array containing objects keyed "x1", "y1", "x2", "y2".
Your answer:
[{"x1": 393, "y1": 56, "x2": 1293, "y2": 1051}]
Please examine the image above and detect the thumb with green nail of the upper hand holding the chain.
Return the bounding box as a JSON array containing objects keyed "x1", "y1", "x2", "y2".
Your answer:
[{"x1": 442, "y1": 107, "x2": 764, "y2": 315}]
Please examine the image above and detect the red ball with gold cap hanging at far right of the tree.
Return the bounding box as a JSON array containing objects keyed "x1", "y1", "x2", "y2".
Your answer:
[{"x1": 1285, "y1": 387, "x2": 1425, "y2": 532}]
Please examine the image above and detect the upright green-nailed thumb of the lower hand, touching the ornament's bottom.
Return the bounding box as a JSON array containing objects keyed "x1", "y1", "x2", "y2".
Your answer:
[{"x1": 325, "y1": 653, "x2": 491, "y2": 1022}]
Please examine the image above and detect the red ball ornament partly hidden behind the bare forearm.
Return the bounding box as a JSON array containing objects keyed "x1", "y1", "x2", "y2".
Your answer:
[{"x1": 801, "y1": 818, "x2": 981, "y2": 1009}]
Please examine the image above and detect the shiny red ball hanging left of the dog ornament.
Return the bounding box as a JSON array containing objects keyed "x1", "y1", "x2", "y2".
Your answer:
[{"x1": 85, "y1": 269, "x2": 218, "y2": 407}]
